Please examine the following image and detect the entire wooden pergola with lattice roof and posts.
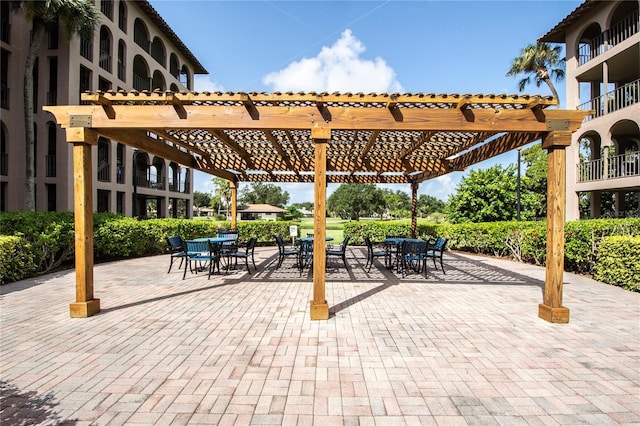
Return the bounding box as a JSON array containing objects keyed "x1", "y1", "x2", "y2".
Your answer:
[{"x1": 44, "y1": 91, "x2": 588, "y2": 323}]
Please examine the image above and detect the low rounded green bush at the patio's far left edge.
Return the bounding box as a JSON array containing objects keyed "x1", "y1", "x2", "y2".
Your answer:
[{"x1": 0, "y1": 235, "x2": 36, "y2": 285}]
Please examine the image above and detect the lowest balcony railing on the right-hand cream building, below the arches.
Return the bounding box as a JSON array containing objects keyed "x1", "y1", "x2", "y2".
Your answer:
[{"x1": 578, "y1": 151, "x2": 640, "y2": 182}]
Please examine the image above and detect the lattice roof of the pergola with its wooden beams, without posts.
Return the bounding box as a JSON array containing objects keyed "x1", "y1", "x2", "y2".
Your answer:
[{"x1": 46, "y1": 91, "x2": 584, "y2": 183}]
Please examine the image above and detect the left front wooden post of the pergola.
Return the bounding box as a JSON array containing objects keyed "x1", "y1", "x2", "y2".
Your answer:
[{"x1": 67, "y1": 127, "x2": 100, "y2": 318}]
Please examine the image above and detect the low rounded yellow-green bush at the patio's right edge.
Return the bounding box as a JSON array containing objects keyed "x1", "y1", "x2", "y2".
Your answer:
[{"x1": 593, "y1": 236, "x2": 640, "y2": 292}]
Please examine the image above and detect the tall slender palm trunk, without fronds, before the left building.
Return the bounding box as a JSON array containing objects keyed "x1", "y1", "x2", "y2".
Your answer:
[{"x1": 24, "y1": 22, "x2": 44, "y2": 211}]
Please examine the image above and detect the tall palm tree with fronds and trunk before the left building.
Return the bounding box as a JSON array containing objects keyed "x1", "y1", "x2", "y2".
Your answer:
[{"x1": 9, "y1": 0, "x2": 100, "y2": 211}]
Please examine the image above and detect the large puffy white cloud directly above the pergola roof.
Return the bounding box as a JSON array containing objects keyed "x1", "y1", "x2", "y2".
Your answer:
[{"x1": 263, "y1": 30, "x2": 403, "y2": 93}]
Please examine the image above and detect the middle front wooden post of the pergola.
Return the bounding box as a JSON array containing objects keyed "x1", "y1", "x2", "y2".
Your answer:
[{"x1": 310, "y1": 128, "x2": 331, "y2": 320}]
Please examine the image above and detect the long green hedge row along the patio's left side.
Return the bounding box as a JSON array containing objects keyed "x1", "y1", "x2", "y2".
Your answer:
[{"x1": 0, "y1": 212, "x2": 298, "y2": 283}]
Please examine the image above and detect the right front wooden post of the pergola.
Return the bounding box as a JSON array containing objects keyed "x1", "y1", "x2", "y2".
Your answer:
[{"x1": 538, "y1": 131, "x2": 571, "y2": 323}]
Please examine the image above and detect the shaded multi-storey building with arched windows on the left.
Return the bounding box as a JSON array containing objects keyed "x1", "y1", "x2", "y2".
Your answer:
[{"x1": 0, "y1": 0, "x2": 207, "y2": 217}]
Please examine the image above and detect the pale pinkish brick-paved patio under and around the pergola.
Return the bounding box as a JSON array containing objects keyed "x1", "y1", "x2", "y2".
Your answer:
[{"x1": 0, "y1": 248, "x2": 640, "y2": 426}]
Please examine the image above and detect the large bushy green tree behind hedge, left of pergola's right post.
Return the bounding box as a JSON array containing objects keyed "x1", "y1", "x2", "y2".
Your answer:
[{"x1": 447, "y1": 164, "x2": 517, "y2": 223}]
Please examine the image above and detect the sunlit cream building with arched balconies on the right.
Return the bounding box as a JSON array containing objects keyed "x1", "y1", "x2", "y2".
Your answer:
[{"x1": 540, "y1": 0, "x2": 640, "y2": 220}]
